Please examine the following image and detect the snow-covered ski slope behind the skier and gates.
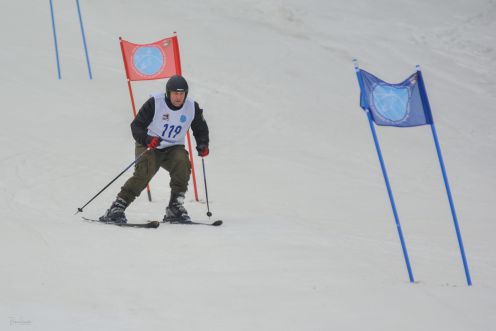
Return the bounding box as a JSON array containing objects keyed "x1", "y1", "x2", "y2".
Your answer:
[{"x1": 0, "y1": 0, "x2": 496, "y2": 330}]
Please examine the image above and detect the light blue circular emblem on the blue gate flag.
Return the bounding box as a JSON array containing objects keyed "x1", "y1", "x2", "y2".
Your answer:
[{"x1": 372, "y1": 84, "x2": 409, "y2": 122}]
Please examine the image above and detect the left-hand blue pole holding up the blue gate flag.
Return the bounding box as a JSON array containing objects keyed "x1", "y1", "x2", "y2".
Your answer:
[{"x1": 353, "y1": 60, "x2": 415, "y2": 283}]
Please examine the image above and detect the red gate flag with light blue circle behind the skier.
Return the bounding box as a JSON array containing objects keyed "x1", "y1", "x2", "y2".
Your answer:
[{"x1": 121, "y1": 36, "x2": 181, "y2": 80}]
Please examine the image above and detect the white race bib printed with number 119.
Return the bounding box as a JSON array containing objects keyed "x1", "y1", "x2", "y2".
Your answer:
[{"x1": 148, "y1": 93, "x2": 195, "y2": 149}]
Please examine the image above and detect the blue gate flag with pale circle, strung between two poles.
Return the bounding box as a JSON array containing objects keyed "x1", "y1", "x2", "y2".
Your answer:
[{"x1": 359, "y1": 69, "x2": 432, "y2": 127}]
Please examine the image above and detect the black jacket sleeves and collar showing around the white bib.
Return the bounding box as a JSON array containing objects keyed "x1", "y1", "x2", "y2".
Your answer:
[{"x1": 131, "y1": 97, "x2": 210, "y2": 146}]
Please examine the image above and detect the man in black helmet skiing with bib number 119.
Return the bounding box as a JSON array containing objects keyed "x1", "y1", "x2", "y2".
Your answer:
[{"x1": 100, "y1": 76, "x2": 209, "y2": 223}]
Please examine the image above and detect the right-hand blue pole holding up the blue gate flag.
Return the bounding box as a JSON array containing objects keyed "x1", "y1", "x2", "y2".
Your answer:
[{"x1": 417, "y1": 65, "x2": 472, "y2": 286}]
